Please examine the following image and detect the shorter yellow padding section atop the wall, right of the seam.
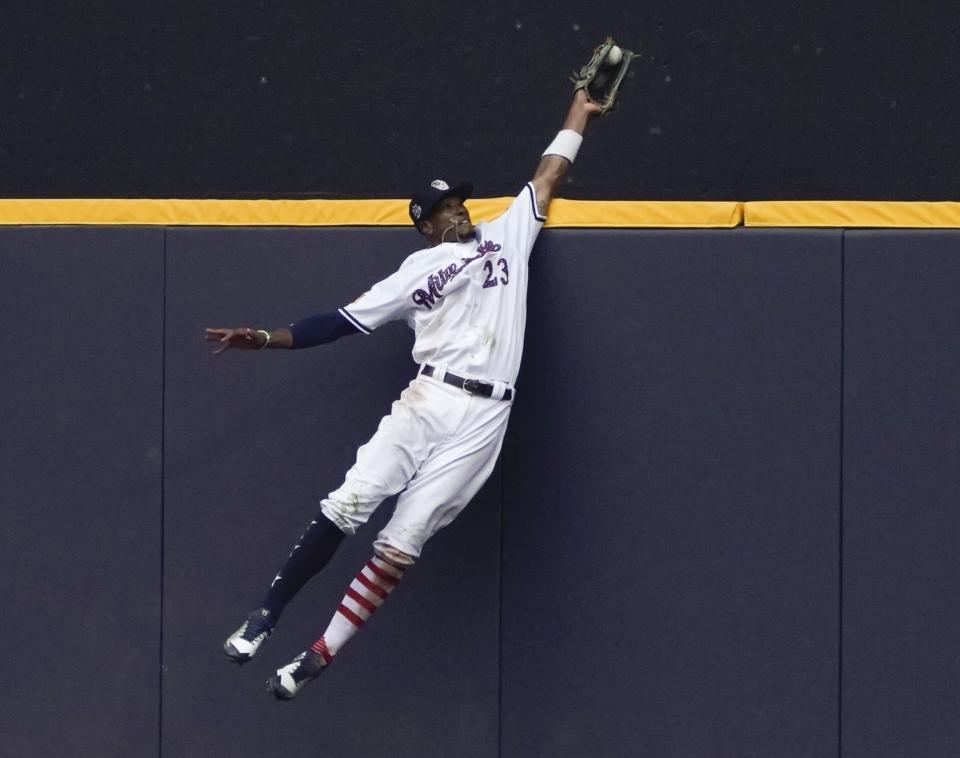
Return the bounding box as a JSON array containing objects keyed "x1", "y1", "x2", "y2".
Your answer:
[{"x1": 743, "y1": 200, "x2": 960, "y2": 229}]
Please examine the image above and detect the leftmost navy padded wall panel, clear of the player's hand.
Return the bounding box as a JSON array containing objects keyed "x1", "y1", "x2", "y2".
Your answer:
[{"x1": 0, "y1": 228, "x2": 164, "y2": 758}]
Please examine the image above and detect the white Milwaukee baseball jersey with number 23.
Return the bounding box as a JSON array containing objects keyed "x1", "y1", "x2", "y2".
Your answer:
[{"x1": 340, "y1": 183, "x2": 546, "y2": 384}]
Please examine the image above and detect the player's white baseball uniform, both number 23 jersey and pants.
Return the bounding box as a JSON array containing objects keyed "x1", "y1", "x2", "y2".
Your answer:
[{"x1": 321, "y1": 184, "x2": 545, "y2": 558}]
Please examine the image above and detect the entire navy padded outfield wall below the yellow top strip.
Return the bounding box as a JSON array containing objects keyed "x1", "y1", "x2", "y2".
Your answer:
[{"x1": 0, "y1": 225, "x2": 960, "y2": 758}]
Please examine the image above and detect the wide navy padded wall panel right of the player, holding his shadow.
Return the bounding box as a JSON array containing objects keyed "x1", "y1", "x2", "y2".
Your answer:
[{"x1": 501, "y1": 230, "x2": 841, "y2": 758}]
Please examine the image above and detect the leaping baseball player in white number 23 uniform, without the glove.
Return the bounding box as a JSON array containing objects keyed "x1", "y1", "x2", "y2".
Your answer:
[{"x1": 206, "y1": 89, "x2": 601, "y2": 700}]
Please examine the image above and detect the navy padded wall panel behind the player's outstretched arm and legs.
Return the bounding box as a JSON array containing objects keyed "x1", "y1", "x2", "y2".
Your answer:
[{"x1": 163, "y1": 229, "x2": 499, "y2": 758}]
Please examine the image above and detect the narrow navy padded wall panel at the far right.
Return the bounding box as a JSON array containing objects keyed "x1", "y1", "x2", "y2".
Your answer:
[{"x1": 843, "y1": 231, "x2": 960, "y2": 758}]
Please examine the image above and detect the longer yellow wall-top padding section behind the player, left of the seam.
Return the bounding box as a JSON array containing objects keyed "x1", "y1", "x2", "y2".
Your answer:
[{"x1": 0, "y1": 197, "x2": 743, "y2": 228}]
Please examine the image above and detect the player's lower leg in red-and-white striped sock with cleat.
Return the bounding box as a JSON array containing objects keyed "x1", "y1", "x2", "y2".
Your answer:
[{"x1": 267, "y1": 546, "x2": 414, "y2": 700}]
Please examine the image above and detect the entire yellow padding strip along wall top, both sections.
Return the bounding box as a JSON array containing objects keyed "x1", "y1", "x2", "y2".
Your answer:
[{"x1": 9, "y1": 197, "x2": 960, "y2": 229}]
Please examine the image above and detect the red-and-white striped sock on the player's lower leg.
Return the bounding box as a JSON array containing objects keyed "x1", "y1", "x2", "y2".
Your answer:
[{"x1": 311, "y1": 556, "x2": 404, "y2": 663}]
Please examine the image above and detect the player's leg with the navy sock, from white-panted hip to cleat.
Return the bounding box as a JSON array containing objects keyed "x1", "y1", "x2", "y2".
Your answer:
[{"x1": 223, "y1": 380, "x2": 456, "y2": 663}]
